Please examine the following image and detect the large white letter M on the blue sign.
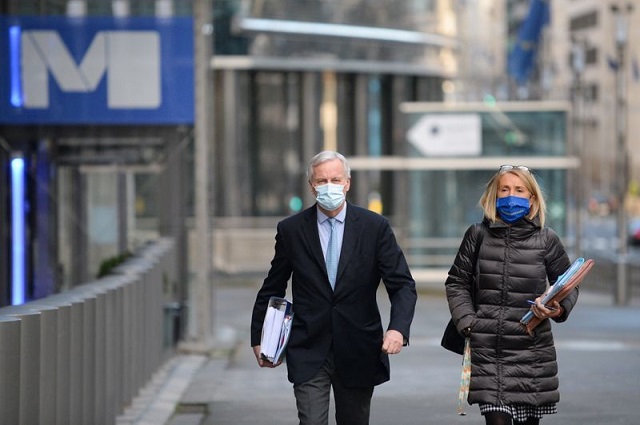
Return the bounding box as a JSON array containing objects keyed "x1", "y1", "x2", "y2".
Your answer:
[{"x1": 21, "y1": 30, "x2": 162, "y2": 109}]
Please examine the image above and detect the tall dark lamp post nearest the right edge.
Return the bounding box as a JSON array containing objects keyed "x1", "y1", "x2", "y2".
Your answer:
[{"x1": 611, "y1": 3, "x2": 633, "y2": 304}]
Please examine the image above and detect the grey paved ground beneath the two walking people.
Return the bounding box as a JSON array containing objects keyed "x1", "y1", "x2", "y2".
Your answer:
[{"x1": 131, "y1": 283, "x2": 640, "y2": 425}]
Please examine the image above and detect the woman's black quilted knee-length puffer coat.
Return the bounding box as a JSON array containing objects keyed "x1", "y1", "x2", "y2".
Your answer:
[{"x1": 445, "y1": 219, "x2": 578, "y2": 406}]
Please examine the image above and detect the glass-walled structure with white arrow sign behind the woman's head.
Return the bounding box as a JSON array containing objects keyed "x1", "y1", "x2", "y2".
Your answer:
[{"x1": 404, "y1": 102, "x2": 577, "y2": 268}]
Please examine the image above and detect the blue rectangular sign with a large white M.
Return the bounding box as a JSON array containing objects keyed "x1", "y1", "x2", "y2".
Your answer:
[{"x1": 0, "y1": 17, "x2": 194, "y2": 125}]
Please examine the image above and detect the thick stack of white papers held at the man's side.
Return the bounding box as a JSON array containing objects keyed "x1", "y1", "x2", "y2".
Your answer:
[{"x1": 260, "y1": 297, "x2": 293, "y2": 363}]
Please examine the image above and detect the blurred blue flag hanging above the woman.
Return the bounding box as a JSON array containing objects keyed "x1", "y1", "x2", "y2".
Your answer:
[{"x1": 507, "y1": 0, "x2": 549, "y2": 84}]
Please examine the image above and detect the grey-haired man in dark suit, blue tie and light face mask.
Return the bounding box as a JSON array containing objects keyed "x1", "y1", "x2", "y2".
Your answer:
[{"x1": 251, "y1": 151, "x2": 417, "y2": 425}]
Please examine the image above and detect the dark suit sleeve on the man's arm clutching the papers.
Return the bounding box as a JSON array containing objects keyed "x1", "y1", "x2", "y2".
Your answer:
[{"x1": 251, "y1": 223, "x2": 292, "y2": 347}]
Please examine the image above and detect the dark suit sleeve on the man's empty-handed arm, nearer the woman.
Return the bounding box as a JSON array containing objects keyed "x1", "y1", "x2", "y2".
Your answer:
[{"x1": 378, "y1": 220, "x2": 418, "y2": 344}]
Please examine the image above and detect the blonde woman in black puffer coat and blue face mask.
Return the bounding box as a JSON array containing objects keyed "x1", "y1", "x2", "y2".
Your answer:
[{"x1": 445, "y1": 166, "x2": 578, "y2": 425}]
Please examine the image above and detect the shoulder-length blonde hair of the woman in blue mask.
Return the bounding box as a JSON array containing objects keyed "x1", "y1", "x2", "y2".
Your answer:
[{"x1": 478, "y1": 168, "x2": 547, "y2": 227}]
